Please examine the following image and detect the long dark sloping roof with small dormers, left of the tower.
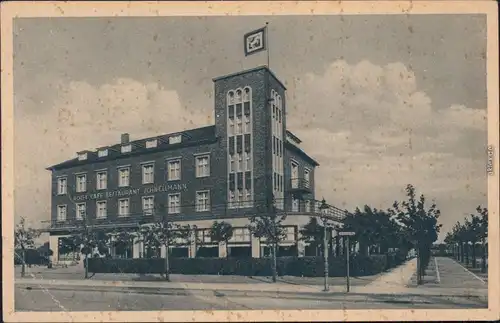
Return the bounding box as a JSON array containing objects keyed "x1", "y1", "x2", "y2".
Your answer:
[{"x1": 47, "y1": 125, "x2": 217, "y2": 170}]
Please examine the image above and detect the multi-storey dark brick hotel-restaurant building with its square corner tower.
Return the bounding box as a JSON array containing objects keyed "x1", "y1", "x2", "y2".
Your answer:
[{"x1": 48, "y1": 67, "x2": 343, "y2": 264}]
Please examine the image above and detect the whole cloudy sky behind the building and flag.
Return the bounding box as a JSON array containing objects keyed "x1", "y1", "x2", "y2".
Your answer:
[{"x1": 14, "y1": 14, "x2": 487, "y2": 240}]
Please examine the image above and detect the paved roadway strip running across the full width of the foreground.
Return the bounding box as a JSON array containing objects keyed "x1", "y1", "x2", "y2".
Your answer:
[{"x1": 15, "y1": 288, "x2": 485, "y2": 311}]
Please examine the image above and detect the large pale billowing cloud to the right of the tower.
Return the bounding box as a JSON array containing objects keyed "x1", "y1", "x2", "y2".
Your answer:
[{"x1": 287, "y1": 60, "x2": 486, "y2": 239}]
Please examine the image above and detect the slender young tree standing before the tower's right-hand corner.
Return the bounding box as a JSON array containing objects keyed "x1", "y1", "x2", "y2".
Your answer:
[{"x1": 248, "y1": 196, "x2": 286, "y2": 283}]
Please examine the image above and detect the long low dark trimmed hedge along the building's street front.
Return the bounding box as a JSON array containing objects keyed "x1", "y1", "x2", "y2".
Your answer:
[{"x1": 88, "y1": 254, "x2": 405, "y2": 277}]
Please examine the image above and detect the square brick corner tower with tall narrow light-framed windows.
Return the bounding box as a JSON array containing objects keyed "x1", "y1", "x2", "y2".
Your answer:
[{"x1": 214, "y1": 66, "x2": 286, "y2": 213}]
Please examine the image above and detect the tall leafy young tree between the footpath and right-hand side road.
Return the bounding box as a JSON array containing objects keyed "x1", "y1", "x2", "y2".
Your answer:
[{"x1": 390, "y1": 184, "x2": 442, "y2": 284}]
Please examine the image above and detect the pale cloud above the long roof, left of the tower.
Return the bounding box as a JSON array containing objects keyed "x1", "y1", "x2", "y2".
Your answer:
[{"x1": 14, "y1": 78, "x2": 213, "y2": 227}]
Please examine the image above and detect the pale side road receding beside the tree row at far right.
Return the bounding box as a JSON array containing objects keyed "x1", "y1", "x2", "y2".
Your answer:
[{"x1": 436, "y1": 257, "x2": 488, "y2": 289}]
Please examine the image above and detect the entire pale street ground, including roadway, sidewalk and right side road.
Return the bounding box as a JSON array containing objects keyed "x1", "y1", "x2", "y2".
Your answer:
[{"x1": 15, "y1": 257, "x2": 488, "y2": 311}]
